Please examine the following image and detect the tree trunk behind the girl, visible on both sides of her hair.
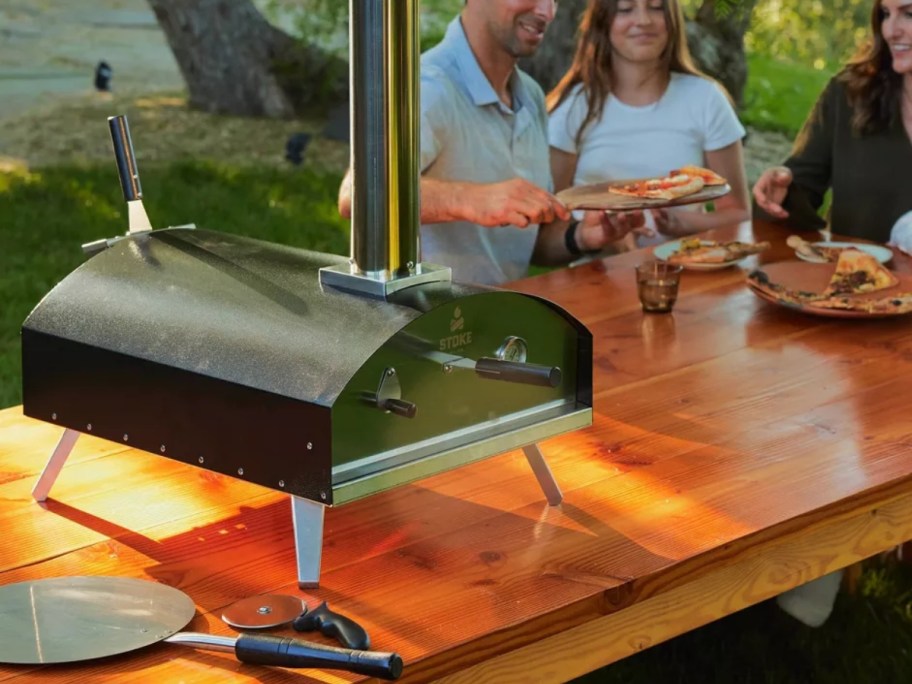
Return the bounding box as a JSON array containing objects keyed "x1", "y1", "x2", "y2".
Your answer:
[{"x1": 520, "y1": 0, "x2": 757, "y2": 105}]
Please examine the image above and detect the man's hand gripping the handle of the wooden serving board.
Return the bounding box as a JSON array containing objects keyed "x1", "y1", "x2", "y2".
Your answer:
[{"x1": 459, "y1": 178, "x2": 570, "y2": 228}]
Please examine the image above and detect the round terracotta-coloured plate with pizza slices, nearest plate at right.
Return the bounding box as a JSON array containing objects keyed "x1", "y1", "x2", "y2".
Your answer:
[{"x1": 747, "y1": 248, "x2": 912, "y2": 318}]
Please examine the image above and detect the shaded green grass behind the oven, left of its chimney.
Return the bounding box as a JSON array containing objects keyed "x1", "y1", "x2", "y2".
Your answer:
[{"x1": 0, "y1": 162, "x2": 348, "y2": 407}]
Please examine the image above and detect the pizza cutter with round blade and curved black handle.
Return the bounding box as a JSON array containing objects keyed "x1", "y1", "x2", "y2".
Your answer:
[{"x1": 222, "y1": 594, "x2": 370, "y2": 650}]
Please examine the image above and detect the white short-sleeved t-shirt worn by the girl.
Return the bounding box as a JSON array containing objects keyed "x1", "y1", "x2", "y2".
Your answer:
[{"x1": 548, "y1": 72, "x2": 745, "y2": 247}]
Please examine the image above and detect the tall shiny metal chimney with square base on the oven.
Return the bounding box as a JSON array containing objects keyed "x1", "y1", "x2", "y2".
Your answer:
[{"x1": 320, "y1": 0, "x2": 450, "y2": 299}]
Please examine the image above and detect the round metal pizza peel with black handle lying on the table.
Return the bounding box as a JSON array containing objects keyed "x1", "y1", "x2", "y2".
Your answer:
[{"x1": 0, "y1": 577, "x2": 402, "y2": 679}]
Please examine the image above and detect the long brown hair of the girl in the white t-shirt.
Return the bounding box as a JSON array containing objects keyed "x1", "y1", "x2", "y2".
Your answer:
[{"x1": 546, "y1": 0, "x2": 712, "y2": 144}]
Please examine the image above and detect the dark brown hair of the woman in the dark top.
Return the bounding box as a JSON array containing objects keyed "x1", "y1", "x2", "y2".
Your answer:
[{"x1": 837, "y1": 0, "x2": 902, "y2": 135}]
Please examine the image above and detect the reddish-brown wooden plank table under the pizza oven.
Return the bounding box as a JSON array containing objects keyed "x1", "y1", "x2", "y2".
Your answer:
[{"x1": 0, "y1": 224, "x2": 912, "y2": 683}]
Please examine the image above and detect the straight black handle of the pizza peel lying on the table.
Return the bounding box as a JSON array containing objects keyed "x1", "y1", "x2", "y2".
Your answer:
[{"x1": 234, "y1": 634, "x2": 402, "y2": 680}]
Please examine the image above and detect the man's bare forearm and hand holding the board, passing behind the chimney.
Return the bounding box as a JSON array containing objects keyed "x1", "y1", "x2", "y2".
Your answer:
[{"x1": 339, "y1": 169, "x2": 569, "y2": 228}]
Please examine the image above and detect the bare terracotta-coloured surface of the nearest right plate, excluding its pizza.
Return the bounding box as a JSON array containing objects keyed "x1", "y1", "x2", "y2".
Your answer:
[{"x1": 747, "y1": 261, "x2": 912, "y2": 318}]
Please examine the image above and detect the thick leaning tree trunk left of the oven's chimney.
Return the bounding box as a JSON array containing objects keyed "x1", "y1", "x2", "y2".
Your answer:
[{"x1": 149, "y1": 0, "x2": 348, "y2": 118}]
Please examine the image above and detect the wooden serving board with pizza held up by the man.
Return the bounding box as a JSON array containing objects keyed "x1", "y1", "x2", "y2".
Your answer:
[{"x1": 557, "y1": 166, "x2": 731, "y2": 211}]
